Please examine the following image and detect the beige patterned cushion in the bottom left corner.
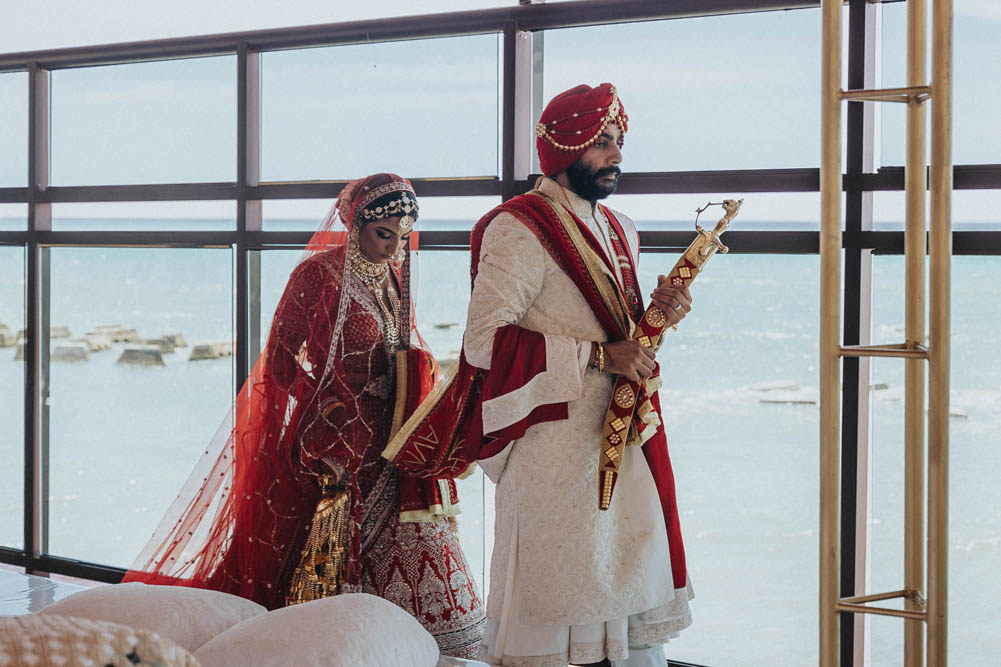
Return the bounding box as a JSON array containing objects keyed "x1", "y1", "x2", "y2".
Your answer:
[{"x1": 0, "y1": 614, "x2": 198, "y2": 667}]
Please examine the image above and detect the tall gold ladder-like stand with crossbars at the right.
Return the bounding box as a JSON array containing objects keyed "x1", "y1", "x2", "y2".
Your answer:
[{"x1": 819, "y1": 0, "x2": 953, "y2": 667}]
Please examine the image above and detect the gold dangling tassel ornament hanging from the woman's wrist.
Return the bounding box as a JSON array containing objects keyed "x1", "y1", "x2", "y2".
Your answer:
[{"x1": 285, "y1": 475, "x2": 348, "y2": 606}]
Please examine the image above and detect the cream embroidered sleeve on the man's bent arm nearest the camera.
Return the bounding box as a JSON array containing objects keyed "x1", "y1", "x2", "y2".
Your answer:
[{"x1": 463, "y1": 213, "x2": 591, "y2": 433}]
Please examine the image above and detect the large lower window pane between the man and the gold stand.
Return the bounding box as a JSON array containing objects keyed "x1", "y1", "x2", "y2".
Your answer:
[{"x1": 640, "y1": 252, "x2": 820, "y2": 667}]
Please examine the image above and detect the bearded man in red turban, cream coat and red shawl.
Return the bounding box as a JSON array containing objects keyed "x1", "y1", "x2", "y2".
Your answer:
[{"x1": 386, "y1": 83, "x2": 692, "y2": 667}]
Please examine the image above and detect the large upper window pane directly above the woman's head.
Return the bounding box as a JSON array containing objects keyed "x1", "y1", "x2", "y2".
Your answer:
[{"x1": 261, "y1": 34, "x2": 498, "y2": 180}]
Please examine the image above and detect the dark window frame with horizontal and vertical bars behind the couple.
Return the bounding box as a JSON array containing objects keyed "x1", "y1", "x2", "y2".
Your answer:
[{"x1": 0, "y1": 5, "x2": 1001, "y2": 665}]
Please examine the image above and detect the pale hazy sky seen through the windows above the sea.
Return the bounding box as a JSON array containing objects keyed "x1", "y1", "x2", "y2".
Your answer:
[{"x1": 0, "y1": 0, "x2": 1001, "y2": 221}]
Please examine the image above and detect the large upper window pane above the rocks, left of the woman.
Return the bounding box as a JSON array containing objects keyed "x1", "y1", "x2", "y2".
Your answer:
[{"x1": 51, "y1": 56, "x2": 236, "y2": 185}]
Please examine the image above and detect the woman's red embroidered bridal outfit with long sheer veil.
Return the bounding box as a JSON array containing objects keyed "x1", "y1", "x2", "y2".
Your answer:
[{"x1": 123, "y1": 174, "x2": 485, "y2": 658}]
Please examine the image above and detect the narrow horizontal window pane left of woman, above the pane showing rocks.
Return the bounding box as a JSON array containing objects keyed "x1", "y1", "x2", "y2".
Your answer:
[{"x1": 52, "y1": 200, "x2": 236, "y2": 231}]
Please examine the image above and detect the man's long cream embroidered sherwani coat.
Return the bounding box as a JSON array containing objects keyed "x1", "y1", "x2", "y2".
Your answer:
[{"x1": 463, "y1": 178, "x2": 692, "y2": 667}]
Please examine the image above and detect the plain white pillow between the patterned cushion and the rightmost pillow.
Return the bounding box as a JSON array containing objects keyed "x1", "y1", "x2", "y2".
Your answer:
[{"x1": 39, "y1": 582, "x2": 267, "y2": 653}]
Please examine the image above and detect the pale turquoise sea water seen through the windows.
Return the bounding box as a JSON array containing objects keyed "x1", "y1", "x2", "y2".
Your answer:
[{"x1": 0, "y1": 222, "x2": 1001, "y2": 666}]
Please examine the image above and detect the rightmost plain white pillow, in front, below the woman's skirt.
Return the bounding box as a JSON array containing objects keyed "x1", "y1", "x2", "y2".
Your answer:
[{"x1": 194, "y1": 593, "x2": 438, "y2": 667}]
